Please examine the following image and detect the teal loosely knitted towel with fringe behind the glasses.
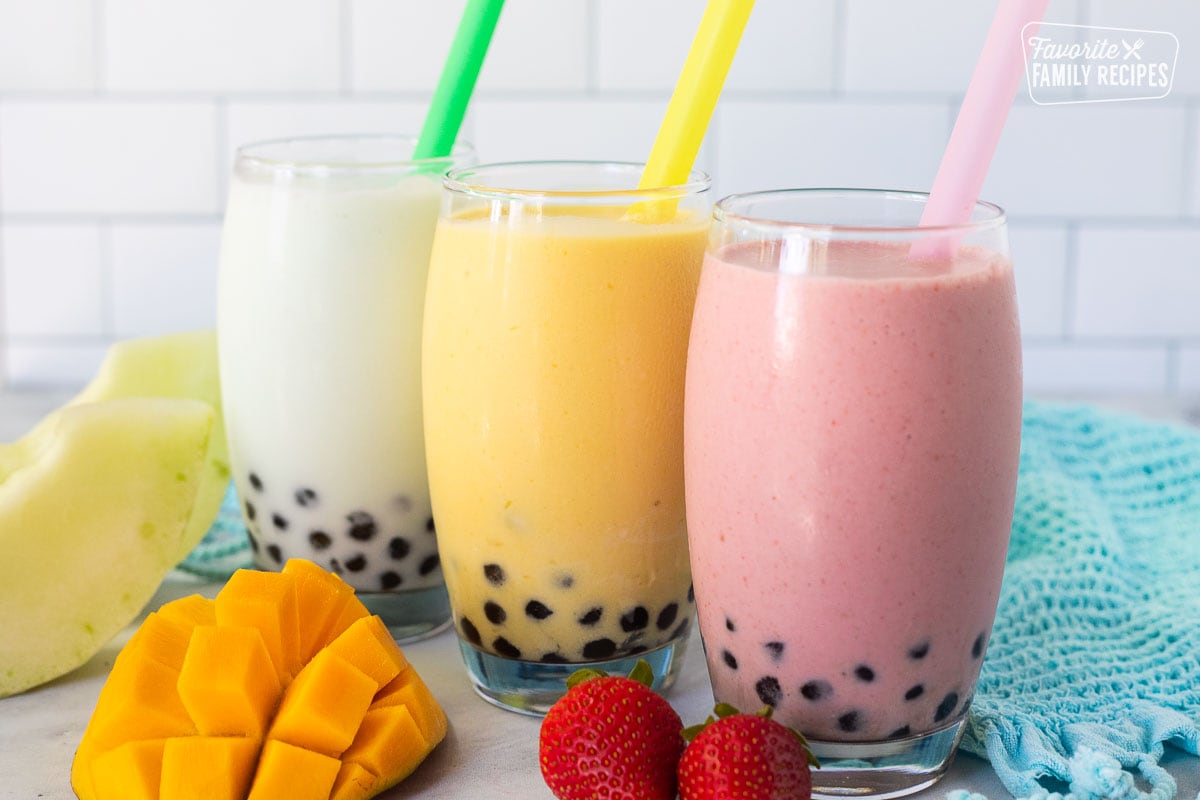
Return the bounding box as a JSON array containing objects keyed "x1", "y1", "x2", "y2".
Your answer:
[{"x1": 181, "y1": 402, "x2": 1200, "y2": 800}]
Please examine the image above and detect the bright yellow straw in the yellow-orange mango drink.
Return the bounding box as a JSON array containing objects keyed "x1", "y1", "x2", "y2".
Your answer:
[{"x1": 638, "y1": 0, "x2": 754, "y2": 188}]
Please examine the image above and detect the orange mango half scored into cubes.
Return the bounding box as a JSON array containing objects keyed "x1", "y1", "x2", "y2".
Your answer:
[{"x1": 71, "y1": 559, "x2": 448, "y2": 800}]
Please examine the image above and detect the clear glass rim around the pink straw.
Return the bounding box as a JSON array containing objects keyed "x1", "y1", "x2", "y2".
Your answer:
[{"x1": 713, "y1": 187, "x2": 1008, "y2": 236}]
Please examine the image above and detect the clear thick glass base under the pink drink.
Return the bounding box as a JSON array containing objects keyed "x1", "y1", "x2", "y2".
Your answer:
[{"x1": 809, "y1": 717, "x2": 965, "y2": 800}]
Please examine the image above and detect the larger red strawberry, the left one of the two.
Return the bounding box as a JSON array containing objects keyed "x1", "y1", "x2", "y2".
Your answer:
[{"x1": 539, "y1": 661, "x2": 685, "y2": 800}]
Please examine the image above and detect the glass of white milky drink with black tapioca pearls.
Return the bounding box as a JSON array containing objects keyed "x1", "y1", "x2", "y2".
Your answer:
[{"x1": 217, "y1": 136, "x2": 474, "y2": 640}]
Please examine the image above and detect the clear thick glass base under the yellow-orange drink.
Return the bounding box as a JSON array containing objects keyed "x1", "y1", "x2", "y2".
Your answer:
[{"x1": 458, "y1": 633, "x2": 688, "y2": 716}]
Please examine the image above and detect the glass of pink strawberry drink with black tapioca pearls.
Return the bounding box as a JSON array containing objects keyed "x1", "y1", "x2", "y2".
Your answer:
[{"x1": 685, "y1": 190, "x2": 1021, "y2": 798}]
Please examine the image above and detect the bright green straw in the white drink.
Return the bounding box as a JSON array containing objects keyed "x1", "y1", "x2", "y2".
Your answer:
[{"x1": 413, "y1": 0, "x2": 504, "y2": 160}]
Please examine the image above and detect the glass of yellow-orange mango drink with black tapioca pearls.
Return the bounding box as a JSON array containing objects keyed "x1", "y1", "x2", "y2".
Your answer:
[{"x1": 422, "y1": 162, "x2": 710, "y2": 714}]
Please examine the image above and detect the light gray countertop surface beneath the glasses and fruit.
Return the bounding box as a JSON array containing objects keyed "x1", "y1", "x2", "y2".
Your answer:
[{"x1": 0, "y1": 392, "x2": 1200, "y2": 800}]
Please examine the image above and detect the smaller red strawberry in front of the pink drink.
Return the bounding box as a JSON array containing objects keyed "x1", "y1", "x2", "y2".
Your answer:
[{"x1": 679, "y1": 703, "x2": 820, "y2": 800}]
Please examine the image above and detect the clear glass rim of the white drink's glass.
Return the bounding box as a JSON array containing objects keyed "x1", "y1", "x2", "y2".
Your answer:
[{"x1": 234, "y1": 133, "x2": 475, "y2": 173}]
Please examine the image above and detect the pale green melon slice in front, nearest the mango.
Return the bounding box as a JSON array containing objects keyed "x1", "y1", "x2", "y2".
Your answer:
[{"x1": 0, "y1": 398, "x2": 215, "y2": 697}]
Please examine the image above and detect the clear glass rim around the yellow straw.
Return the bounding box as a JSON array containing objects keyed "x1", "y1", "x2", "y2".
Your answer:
[{"x1": 442, "y1": 158, "x2": 713, "y2": 201}]
